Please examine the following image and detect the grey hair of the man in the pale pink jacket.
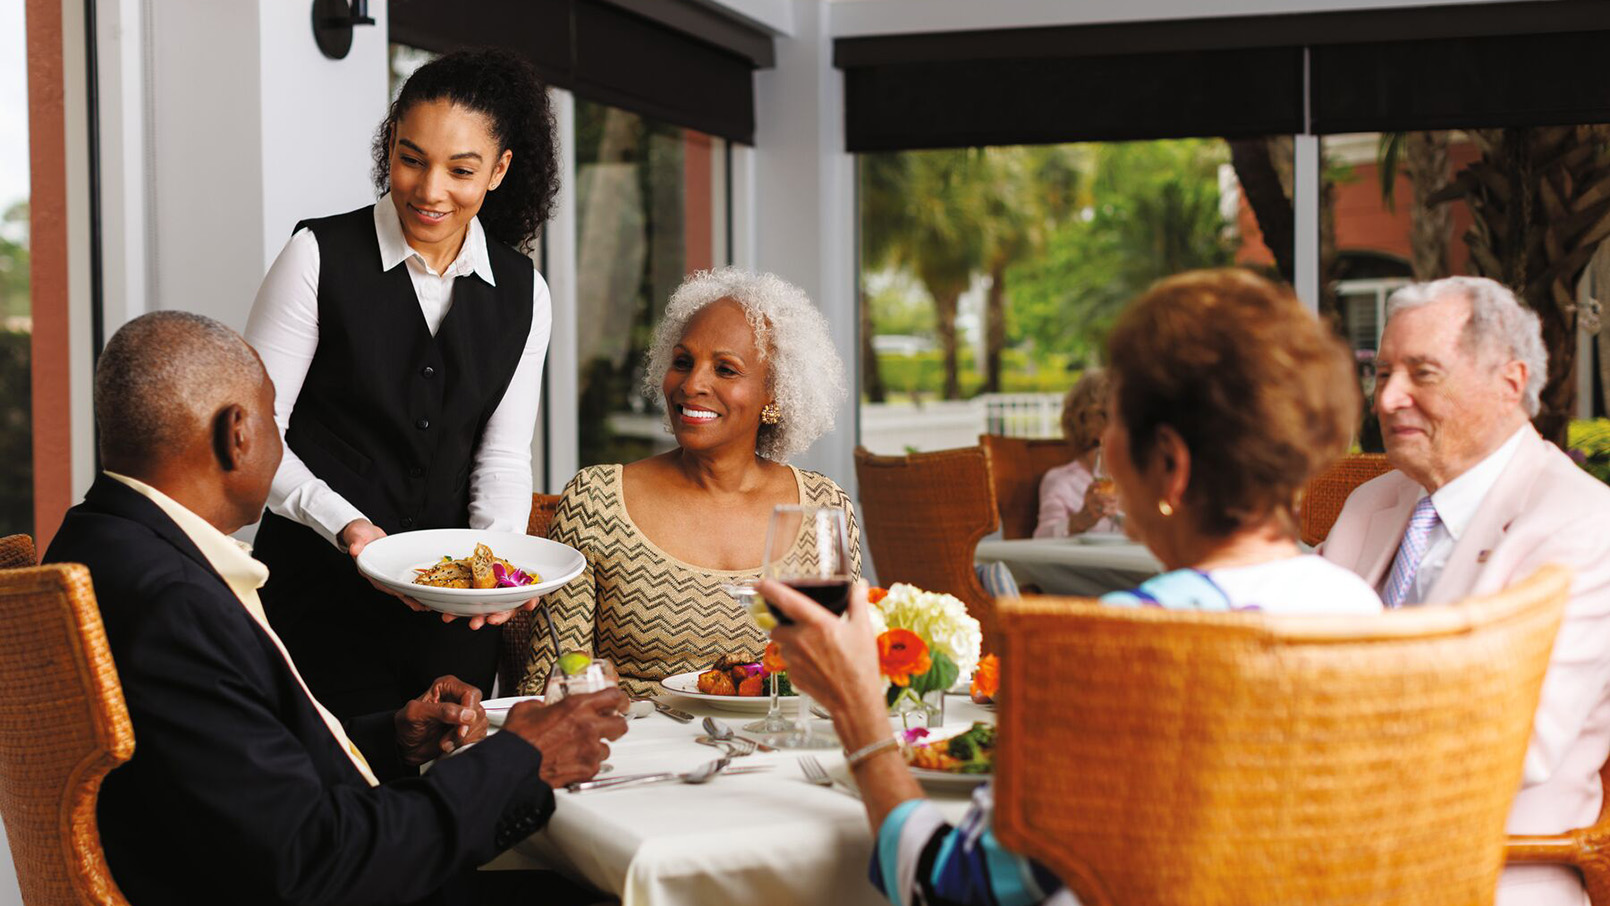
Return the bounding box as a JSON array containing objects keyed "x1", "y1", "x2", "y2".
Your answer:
[{"x1": 1386, "y1": 277, "x2": 1549, "y2": 417}]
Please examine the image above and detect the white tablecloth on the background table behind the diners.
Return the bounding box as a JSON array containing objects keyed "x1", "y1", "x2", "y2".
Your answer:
[{"x1": 972, "y1": 537, "x2": 1162, "y2": 597}]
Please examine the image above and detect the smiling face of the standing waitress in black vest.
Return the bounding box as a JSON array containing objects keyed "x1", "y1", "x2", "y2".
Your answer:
[{"x1": 391, "y1": 100, "x2": 514, "y2": 260}]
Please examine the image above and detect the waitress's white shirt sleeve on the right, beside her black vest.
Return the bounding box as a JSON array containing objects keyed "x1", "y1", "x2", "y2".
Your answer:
[{"x1": 466, "y1": 274, "x2": 554, "y2": 533}]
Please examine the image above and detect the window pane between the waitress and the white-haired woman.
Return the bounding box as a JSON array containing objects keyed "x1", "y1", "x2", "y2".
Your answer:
[{"x1": 575, "y1": 98, "x2": 729, "y2": 465}]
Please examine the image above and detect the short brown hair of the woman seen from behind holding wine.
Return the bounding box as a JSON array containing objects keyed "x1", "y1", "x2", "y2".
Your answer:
[{"x1": 1108, "y1": 269, "x2": 1360, "y2": 536}]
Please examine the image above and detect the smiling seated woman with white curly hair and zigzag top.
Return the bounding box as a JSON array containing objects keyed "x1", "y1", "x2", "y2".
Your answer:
[{"x1": 520, "y1": 267, "x2": 861, "y2": 694}]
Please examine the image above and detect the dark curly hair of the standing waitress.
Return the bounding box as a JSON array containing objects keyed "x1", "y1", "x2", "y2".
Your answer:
[{"x1": 374, "y1": 50, "x2": 559, "y2": 251}]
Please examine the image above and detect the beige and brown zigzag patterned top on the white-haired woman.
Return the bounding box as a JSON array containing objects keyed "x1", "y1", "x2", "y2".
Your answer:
[{"x1": 520, "y1": 465, "x2": 861, "y2": 695}]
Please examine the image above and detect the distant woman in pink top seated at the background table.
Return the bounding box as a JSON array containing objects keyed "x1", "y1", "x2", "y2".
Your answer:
[{"x1": 1034, "y1": 369, "x2": 1119, "y2": 537}]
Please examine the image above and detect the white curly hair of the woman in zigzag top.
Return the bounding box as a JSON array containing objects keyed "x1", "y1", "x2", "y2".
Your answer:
[{"x1": 642, "y1": 267, "x2": 848, "y2": 462}]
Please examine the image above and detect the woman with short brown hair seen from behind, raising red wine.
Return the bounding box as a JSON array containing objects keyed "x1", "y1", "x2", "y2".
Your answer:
[{"x1": 762, "y1": 270, "x2": 1381, "y2": 903}]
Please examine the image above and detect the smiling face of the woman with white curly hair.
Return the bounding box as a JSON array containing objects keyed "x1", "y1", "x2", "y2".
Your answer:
[{"x1": 662, "y1": 299, "x2": 771, "y2": 452}]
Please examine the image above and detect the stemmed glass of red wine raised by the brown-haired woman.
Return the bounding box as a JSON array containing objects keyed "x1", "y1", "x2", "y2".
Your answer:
[{"x1": 762, "y1": 505, "x2": 853, "y2": 748}]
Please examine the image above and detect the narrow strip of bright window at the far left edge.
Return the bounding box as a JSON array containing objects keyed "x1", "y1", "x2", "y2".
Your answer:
[{"x1": 0, "y1": 3, "x2": 34, "y2": 536}]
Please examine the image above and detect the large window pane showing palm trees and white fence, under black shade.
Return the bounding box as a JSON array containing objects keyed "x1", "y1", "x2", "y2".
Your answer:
[{"x1": 858, "y1": 138, "x2": 1291, "y2": 454}]
